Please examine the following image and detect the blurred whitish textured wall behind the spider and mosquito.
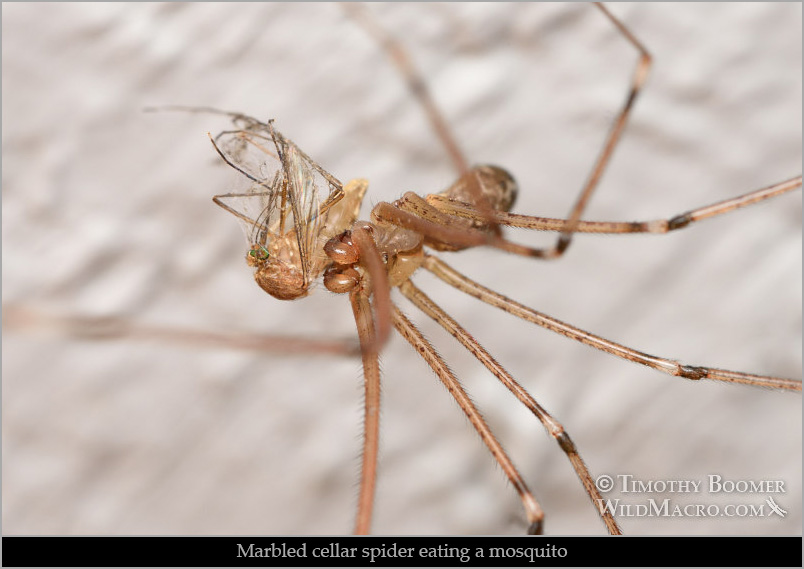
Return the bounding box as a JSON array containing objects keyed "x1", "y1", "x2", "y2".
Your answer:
[{"x1": 2, "y1": 3, "x2": 802, "y2": 535}]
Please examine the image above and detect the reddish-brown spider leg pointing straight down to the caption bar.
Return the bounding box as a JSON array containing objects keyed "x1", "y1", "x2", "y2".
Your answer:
[{"x1": 349, "y1": 289, "x2": 380, "y2": 535}]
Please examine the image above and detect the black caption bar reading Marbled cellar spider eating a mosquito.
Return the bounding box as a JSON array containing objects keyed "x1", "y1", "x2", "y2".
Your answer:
[{"x1": 2, "y1": 536, "x2": 802, "y2": 567}]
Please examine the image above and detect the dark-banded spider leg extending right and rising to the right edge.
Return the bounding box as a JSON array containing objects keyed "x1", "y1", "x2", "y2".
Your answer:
[{"x1": 426, "y1": 176, "x2": 801, "y2": 234}]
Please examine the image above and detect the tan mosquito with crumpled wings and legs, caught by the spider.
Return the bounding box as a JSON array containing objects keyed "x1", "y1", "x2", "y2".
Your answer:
[{"x1": 213, "y1": 116, "x2": 344, "y2": 299}]
